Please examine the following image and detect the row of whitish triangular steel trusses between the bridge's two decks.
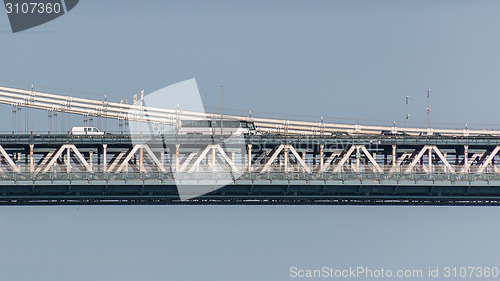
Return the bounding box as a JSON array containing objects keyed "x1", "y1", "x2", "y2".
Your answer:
[{"x1": 0, "y1": 135, "x2": 500, "y2": 174}]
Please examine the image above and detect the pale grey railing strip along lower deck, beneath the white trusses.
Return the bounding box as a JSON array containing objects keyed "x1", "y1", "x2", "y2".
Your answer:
[{"x1": 0, "y1": 172, "x2": 500, "y2": 184}]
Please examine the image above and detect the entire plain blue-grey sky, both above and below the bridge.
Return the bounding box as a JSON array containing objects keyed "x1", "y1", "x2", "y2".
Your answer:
[{"x1": 0, "y1": 0, "x2": 500, "y2": 281}]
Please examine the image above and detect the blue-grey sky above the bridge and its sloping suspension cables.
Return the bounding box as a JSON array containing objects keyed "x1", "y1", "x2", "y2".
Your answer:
[{"x1": 0, "y1": 0, "x2": 500, "y2": 130}]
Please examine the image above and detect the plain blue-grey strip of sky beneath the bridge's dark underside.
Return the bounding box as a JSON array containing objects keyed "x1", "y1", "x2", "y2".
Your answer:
[{"x1": 0, "y1": 203, "x2": 500, "y2": 281}]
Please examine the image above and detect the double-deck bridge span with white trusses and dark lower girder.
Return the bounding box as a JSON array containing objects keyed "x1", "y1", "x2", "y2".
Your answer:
[{"x1": 0, "y1": 134, "x2": 500, "y2": 205}]
